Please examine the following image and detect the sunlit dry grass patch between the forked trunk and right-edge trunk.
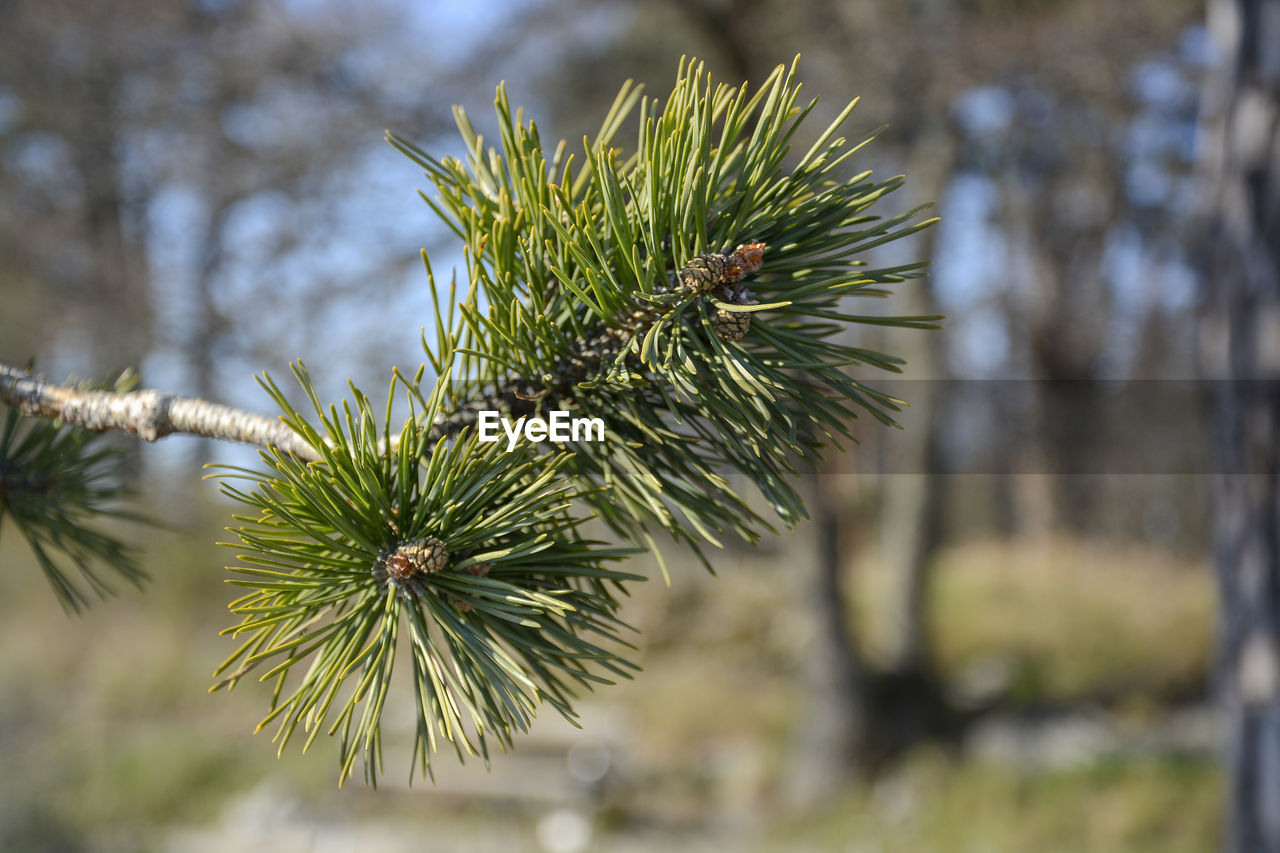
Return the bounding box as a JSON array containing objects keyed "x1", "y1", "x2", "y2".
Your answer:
[{"x1": 855, "y1": 539, "x2": 1215, "y2": 703}]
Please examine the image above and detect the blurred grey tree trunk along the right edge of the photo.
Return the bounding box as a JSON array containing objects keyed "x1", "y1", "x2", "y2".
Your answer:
[{"x1": 1201, "y1": 0, "x2": 1280, "y2": 853}]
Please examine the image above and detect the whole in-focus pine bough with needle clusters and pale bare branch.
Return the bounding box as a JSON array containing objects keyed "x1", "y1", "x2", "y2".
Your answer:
[{"x1": 0, "y1": 61, "x2": 937, "y2": 783}]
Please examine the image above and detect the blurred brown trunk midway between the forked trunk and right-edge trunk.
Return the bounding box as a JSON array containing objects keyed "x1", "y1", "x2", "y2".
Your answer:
[{"x1": 1001, "y1": 128, "x2": 1124, "y2": 538}]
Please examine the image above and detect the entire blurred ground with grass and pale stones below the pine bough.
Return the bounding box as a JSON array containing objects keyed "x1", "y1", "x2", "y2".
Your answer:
[{"x1": 0, "y1": 489, "x2": 1221, "y2": 853}]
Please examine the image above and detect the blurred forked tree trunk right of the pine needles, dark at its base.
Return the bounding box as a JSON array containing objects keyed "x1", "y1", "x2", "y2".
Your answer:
[{"x1": 788, "y1": 0, "x2": 955, "y2": 803}]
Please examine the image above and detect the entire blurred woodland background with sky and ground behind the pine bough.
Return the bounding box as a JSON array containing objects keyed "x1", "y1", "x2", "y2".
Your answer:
[{"x1": 0, "y1": 0, "x2": 1259, "y2": 853}]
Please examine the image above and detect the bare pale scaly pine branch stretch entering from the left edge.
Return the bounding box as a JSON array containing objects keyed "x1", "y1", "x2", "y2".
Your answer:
[{"x1": 0, "y1": 362, "x2": 320, "y2": 461}]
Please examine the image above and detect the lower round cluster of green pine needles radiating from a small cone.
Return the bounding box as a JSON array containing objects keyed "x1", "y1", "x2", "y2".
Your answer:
[{"x1": 215, "y1": 365, "x2": 641, "y2": 784}]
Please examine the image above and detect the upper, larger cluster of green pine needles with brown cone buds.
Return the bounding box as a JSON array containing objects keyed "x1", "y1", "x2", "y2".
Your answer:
[{"x1": 390, "y1": 54, "x2": 940, "y2": 553}]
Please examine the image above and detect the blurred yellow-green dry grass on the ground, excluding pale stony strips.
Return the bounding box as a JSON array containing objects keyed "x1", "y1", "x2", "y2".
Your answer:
[{"x1": 0, "y1": 499, "x2": 1219, "y2": 852}]
